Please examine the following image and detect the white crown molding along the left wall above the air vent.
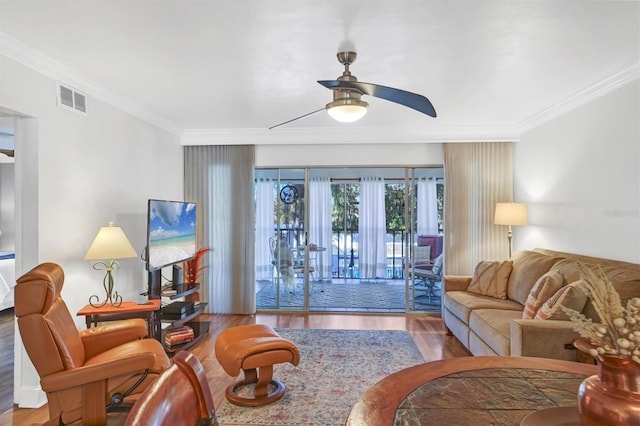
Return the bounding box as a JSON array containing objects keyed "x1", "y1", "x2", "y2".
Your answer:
[{"x1": 0, "y1": 31, "x2": 182, "y2": 136}]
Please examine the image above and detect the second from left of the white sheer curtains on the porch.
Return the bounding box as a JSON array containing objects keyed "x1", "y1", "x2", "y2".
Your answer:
[{"x1": 309, "y1": 177, "x2": 333, "y2": 279}]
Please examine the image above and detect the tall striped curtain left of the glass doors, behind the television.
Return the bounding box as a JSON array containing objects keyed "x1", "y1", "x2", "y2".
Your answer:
[{"x1": 184, "y1": 145, "x2": 256, "y2": 314}]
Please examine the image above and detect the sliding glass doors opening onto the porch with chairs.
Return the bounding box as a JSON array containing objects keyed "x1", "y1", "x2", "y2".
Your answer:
[{"x1": 256, "y1": 168, "x2": 442, "y2": 313}]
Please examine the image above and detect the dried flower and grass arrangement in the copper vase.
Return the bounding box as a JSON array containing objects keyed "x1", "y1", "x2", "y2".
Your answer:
[{"x1": 562, "y1": 263, "x2": 640, "y2": 364}]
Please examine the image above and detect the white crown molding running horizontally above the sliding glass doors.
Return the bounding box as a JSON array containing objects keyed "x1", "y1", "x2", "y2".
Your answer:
[{"x1": 180, "y1": 126, "x2": 519, "y2": 145}]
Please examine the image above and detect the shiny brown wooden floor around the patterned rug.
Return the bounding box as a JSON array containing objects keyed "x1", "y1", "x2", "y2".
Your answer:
[{"x1": 0, "y1": 314, "x2": 470, "y2": 426}]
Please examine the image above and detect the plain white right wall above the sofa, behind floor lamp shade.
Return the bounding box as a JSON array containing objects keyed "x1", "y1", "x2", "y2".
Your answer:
[{"x1": 514, "y1": 80, "x2": 640, "y2": 263}]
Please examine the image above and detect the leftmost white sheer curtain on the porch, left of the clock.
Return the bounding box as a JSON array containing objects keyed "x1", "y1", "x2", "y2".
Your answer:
[{"x1": 255, "y1": 179, "x2": 275, "y2": 280}]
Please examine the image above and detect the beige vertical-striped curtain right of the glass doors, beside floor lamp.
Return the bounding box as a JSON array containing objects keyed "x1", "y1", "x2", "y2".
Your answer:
[{"x1": 443, "y1": 142, "x2": 513, "y2": 275}]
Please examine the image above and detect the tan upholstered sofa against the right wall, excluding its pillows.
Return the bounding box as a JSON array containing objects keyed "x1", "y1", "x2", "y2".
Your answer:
[{"x1": 442, "y1": 249, "x2": 640, "y2": 361}]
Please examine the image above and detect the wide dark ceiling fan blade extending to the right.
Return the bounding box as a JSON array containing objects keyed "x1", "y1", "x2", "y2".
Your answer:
[{"x1": 318, "y1": 80, "x2": 436, "y2": 117}]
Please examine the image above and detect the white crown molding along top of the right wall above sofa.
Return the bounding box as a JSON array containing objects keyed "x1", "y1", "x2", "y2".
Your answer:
[{"x1": 516, "y1": 62, "x2": 640, "y2": 134}]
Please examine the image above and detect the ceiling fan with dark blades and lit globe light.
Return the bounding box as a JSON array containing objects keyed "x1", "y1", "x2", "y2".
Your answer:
[{"x1": 269, "y1": 51, "x2": 436, "y2": 129}]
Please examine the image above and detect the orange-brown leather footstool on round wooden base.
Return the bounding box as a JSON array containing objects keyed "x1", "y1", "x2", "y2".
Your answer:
[{"x1": 216, "y1": 324, "x2": 300, "y2": 407}]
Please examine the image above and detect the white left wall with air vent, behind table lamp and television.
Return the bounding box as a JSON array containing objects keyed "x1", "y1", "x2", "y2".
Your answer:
[{"x1": 0, "y1": 55, "x2": 183, "y2": 406}]
